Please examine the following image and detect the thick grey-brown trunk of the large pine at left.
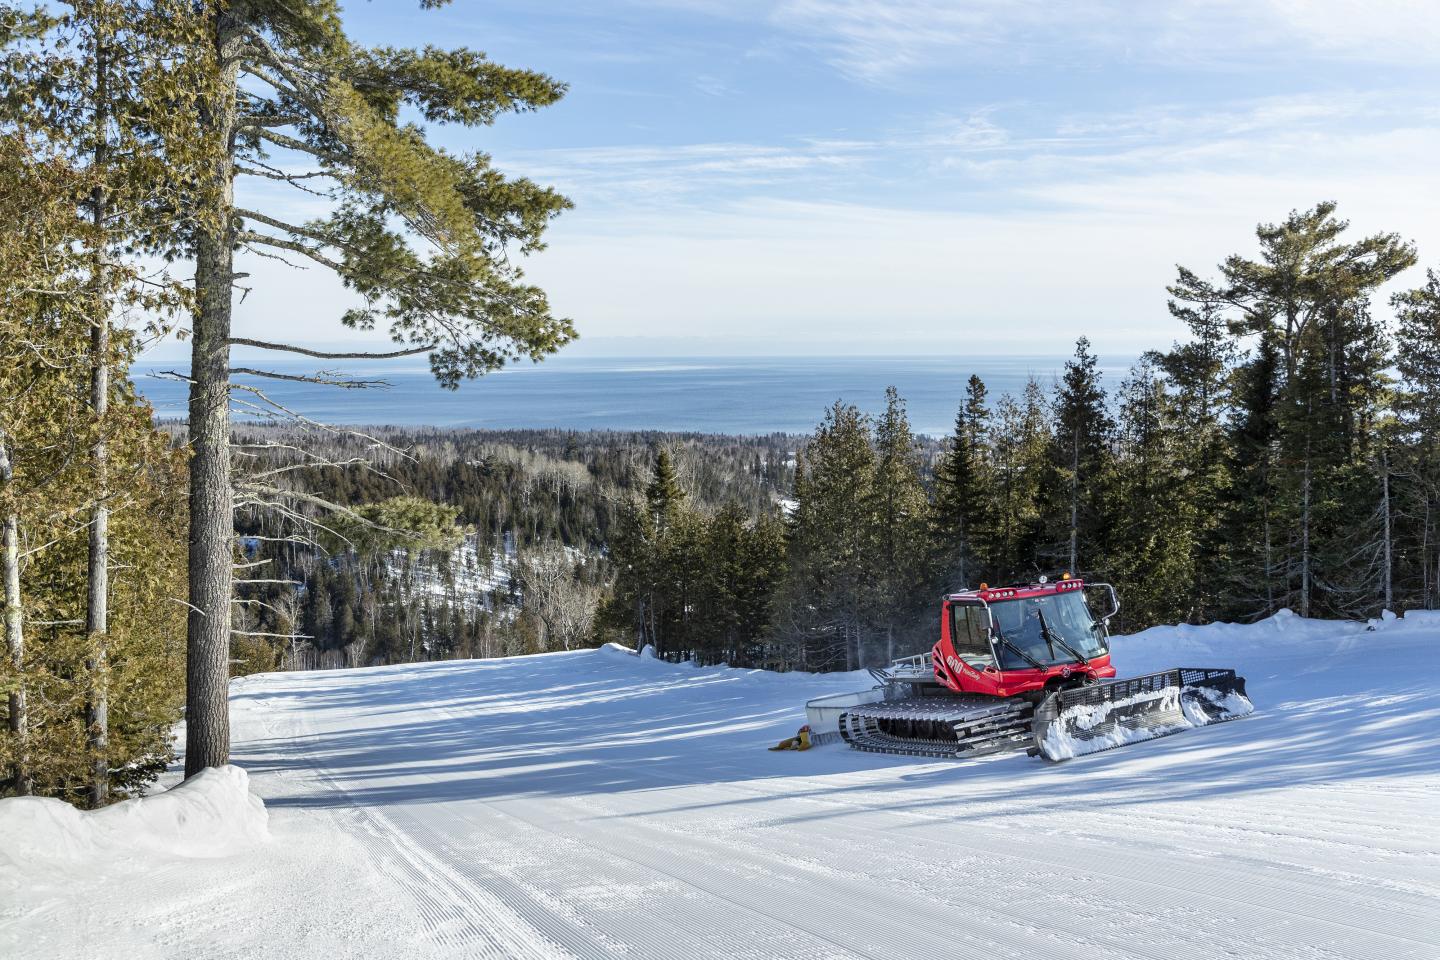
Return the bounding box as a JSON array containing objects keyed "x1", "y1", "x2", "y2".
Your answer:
[{"x1": 184, "y1": 3, "x2": 243, "y2": 777}]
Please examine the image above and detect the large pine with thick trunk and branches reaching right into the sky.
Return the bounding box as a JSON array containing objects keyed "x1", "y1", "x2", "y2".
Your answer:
[{"x1": 174, "y1": 0, "x2": 573, "y2": 776}]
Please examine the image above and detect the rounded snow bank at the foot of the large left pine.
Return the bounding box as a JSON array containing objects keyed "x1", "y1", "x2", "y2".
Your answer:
[{"x1": 0, "y1": 766, "x2": 269, "y2": 864}]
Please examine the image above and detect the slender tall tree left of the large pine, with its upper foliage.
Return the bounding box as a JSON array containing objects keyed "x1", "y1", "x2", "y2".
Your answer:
[{"x1": 0, "y1": 0, "x2": 206, "y2": 806}]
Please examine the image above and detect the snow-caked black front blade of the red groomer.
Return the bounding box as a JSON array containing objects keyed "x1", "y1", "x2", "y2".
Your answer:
[{"x1": 1034, "y1": 666, "x2": 1254, "y2": 761}]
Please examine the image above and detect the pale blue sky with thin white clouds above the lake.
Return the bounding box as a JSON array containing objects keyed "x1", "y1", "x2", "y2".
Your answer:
[{"x1": 208, "y1": 0, "x2": 1440, "y2": 354}]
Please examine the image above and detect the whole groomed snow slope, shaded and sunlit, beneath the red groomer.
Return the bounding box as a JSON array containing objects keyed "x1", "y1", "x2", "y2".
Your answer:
[{"x1": 0, "y1": 615, "x2": 1440, "y2": 960}]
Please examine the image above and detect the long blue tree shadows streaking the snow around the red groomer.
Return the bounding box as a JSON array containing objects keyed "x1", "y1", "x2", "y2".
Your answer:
[{"x1": 232, "y1": 644, "x2": 1440, "y2": 820}]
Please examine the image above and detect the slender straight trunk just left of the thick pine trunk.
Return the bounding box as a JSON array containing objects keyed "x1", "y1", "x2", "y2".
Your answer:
[{"x1": 85, "y1": 39, "x2": 109, "y2": 806}]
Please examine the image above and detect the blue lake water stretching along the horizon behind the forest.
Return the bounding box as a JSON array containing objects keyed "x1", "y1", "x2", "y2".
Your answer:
[{"x1": 132, "y1": 357, "x2": 1133, "y2": 436}]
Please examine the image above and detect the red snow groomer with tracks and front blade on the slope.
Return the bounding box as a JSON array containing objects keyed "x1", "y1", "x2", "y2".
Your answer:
[{"x1": 806, "y1": 574, "x2": 1254, "y2": 760}]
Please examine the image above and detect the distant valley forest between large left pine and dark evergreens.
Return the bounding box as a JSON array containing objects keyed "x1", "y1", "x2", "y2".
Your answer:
[{"x1": 218, "y1": 425, "x2": 796, "y2": 672}]
